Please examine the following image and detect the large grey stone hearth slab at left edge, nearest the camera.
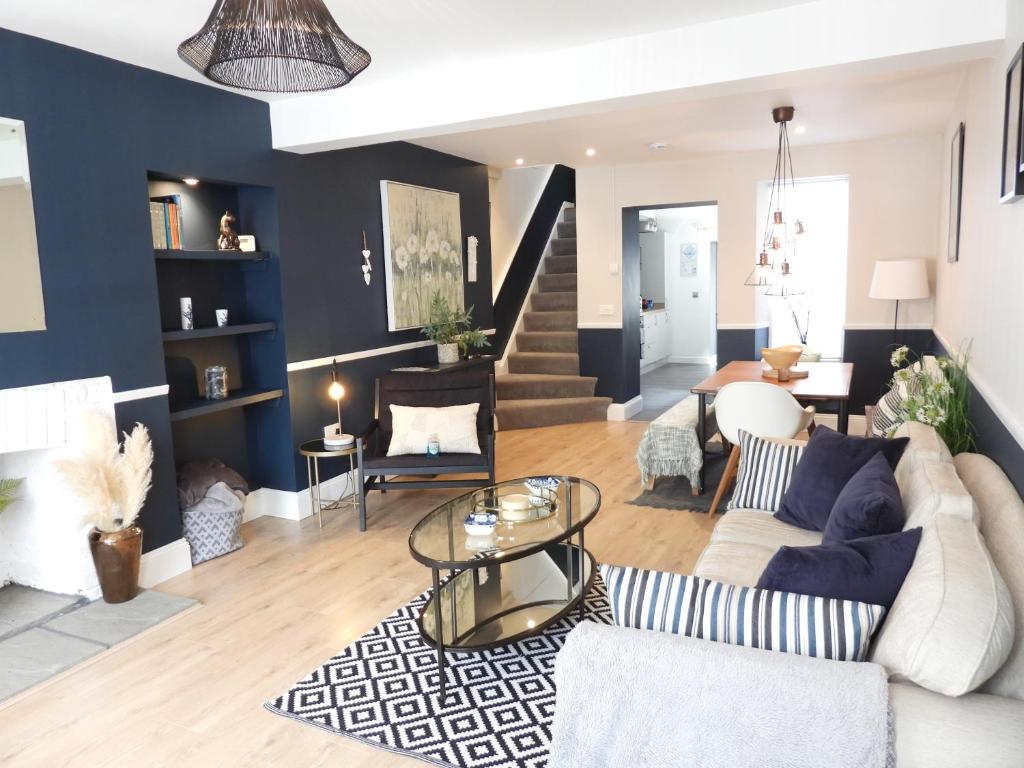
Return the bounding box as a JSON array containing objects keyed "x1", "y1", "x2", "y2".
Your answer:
[{"x1": 0, "y1": 628, "x2": 104, "y2": 700}]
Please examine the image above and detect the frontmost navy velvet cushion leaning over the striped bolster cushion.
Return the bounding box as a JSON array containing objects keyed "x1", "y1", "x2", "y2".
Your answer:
[{"x1": 758, "y1": 528, "x2": 921, "y2": 608}]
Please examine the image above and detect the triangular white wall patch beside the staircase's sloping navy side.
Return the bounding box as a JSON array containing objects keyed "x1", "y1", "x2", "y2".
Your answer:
[{"x1": 488, "y1": 165, "x2": 555, "y2": 299}]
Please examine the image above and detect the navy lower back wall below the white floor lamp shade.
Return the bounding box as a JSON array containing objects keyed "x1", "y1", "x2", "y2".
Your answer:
[{"x1": 843, "y1": 329, "x2": 935, "y2": 414}]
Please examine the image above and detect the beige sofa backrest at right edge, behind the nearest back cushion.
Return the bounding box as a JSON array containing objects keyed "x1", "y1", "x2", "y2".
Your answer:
[{"x1": 955, "y1": 454, "x2": 1024, "y2": 704}]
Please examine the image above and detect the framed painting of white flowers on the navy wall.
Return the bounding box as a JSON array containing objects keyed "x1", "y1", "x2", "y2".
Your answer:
[{"x1": 381, "y1": 181, "x2": 465, "y2": 331}]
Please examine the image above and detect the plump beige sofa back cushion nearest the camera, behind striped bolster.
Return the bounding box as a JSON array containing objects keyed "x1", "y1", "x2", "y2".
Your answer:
[{"x1": 870, "y1": 514, "x2": 1014, "y2": 696}]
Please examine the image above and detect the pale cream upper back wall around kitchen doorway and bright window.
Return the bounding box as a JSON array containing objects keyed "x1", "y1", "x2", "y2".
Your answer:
[{"x1": 577, "y1": 135, "x2": 942, "y2": 328}]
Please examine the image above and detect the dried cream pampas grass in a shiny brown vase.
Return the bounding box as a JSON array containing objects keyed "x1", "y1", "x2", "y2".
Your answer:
[{"x1": 54, "y1": 413, "x2": 153, "y2": 603}]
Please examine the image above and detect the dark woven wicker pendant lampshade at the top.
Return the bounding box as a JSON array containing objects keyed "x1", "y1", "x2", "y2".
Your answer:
[{"x1": 178, "y1": 0, "x2": 370, "y2": 93}]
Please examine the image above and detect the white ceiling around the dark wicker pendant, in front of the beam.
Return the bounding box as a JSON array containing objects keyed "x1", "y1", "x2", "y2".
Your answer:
[{"x1": 0, "y1": 0, "x2": 809, "y2": 100}]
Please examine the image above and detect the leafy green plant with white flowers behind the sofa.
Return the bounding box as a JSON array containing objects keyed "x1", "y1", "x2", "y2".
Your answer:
[{"x1": 888, "y1": 346, "x2": 974, "y2": 455}]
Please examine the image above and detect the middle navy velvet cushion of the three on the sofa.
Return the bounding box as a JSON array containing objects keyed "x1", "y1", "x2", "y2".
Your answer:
[{"x1": 821, "y1": 452, "x2": 904, "y2": 544}]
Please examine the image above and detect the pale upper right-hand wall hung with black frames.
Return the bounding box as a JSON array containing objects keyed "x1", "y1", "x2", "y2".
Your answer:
[{"x1": 935, "y1": 2, "x2": 1024, "y2": 444}]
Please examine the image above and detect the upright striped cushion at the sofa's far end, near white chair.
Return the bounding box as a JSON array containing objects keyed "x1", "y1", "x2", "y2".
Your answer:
[{"x1": 727, "y1": 429, "x2": 807, "y2": 512}]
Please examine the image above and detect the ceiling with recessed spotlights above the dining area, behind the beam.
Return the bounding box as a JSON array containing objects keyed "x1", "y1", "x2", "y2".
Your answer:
[{"x1": 416, "y1": 65, "x2": 966, "y2": 168}]
